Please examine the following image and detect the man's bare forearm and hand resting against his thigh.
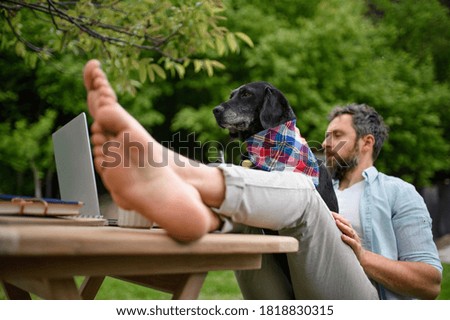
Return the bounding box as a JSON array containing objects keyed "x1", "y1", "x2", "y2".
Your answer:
[{"x1": 333, "y1": 213, "x2": 442, "y2": 299}]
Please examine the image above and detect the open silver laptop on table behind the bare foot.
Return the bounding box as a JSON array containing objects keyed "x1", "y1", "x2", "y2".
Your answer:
[{"x1": 52, "y1": 112, "x2": 117, "y2": 225}]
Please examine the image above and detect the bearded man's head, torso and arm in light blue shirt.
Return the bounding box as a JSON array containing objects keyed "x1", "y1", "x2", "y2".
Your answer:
[{"x1": 323, "y1": 105, "x2": 441, "y2": 299}]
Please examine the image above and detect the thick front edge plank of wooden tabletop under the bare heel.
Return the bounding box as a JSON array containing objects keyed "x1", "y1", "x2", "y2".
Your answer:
[{"x1": 0, "y1": 225, "x2": 298, "y2": 257}]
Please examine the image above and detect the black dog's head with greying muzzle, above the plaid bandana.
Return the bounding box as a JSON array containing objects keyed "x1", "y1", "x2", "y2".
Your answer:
[{"x1": 213, "y1": 82, "x2": 295, "y2": 140}]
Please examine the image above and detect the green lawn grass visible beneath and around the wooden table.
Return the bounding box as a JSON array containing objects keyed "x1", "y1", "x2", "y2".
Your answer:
[{"x1": 0, "y1": 264, "x2": 450, "y2": 300}]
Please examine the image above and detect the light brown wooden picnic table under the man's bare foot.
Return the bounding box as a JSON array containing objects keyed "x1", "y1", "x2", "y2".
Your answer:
[{"x1": 0, "y1": 217, "x2": 298, "y2": 299}]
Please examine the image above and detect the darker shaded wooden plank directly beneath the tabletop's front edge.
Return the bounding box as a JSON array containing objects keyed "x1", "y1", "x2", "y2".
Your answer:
[{"x1": 0, "y1": 254, "x2": 261, "y2": 280}]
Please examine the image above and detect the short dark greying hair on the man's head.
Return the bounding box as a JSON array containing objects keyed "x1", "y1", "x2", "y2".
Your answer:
[{"x1": 328, "y1": 104, "x2": 389, "y2": 161}]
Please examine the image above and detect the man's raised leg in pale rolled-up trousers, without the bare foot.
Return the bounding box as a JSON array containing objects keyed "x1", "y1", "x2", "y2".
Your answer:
[{"x1": 216, "y1": 166, "x2": 378, "y2": 299}]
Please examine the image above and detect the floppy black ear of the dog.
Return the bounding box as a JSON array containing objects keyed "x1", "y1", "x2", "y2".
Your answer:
[{"x1": 259, "y1": 86, "x2": 295, "y2": 129}]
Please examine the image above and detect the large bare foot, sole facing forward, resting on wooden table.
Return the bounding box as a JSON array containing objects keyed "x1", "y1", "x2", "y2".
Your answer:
[{"x1": 84, "y1": 60, "x2": 219, "y2": 241}]
